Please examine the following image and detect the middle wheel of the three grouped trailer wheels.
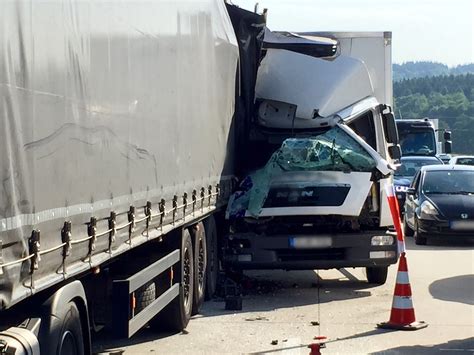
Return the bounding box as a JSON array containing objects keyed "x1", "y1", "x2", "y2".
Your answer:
[{"x1": 191, "y1": 222, "x2": 207, "y2": 314}]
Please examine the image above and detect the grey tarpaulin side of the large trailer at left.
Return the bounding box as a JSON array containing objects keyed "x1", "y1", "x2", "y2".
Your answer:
[{"x1": 0, "y1": 0, "x2": 238, "y2": 308}]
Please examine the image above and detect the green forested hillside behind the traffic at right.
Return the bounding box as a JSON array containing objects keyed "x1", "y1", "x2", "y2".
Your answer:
[{"x1": 393, "y1": 74, "x2": 474, "y2": 154}]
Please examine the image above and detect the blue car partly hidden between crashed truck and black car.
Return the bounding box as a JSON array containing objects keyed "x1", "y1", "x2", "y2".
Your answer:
[{"x1": 394, "y1": 156, "x2": 443, "y2": 216}]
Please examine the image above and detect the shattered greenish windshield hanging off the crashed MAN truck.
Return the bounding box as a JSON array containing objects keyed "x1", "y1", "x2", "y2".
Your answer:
[{"x1": 227, "y1": 126, "x2": 377, "y2": 218}]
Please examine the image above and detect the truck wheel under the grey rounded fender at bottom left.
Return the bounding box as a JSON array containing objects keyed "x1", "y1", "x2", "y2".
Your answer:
[{"x1": 57, "y1": 302, "x2": 84, "y2": 355}]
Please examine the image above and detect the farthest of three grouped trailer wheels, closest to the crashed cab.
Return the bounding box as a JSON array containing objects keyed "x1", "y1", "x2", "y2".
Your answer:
[{"x1": 204, "y1": 216, "x2": 219, "y2": 300}]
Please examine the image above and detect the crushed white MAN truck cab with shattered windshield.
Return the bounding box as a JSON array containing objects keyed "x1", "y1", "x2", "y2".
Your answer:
[{"x1": 224, "y1": 30, "x2": 400, "y2": 273}]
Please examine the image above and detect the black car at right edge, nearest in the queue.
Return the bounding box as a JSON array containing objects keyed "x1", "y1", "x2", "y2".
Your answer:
[{"x1": 403, "y1": 165, "x2": 474, "y2": 245}]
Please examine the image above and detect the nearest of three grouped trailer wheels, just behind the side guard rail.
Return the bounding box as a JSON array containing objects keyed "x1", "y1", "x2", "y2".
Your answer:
[{"x1": 150, "y1": 229, "x2": 194, "y2": 332}]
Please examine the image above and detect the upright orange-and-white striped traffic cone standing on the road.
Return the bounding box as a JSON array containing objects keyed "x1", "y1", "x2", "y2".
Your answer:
[{"x1": 377, "y1": 252, "x2": 428, "y2": 330}]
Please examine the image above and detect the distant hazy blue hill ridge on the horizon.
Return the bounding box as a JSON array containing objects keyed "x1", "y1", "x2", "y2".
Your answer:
[{"x1": 393, "y1": 62, "x2": 474, "y2": 81}]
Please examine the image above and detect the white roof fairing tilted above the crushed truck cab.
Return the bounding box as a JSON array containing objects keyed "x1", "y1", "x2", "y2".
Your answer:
[{"x1": 255, "y1": 49, "x2": 374, "y2": 128}]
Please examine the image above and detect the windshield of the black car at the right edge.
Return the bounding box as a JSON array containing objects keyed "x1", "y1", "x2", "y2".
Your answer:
[{"x1": 422, "y1": 170, "x2": 474, "y2": 195}]
